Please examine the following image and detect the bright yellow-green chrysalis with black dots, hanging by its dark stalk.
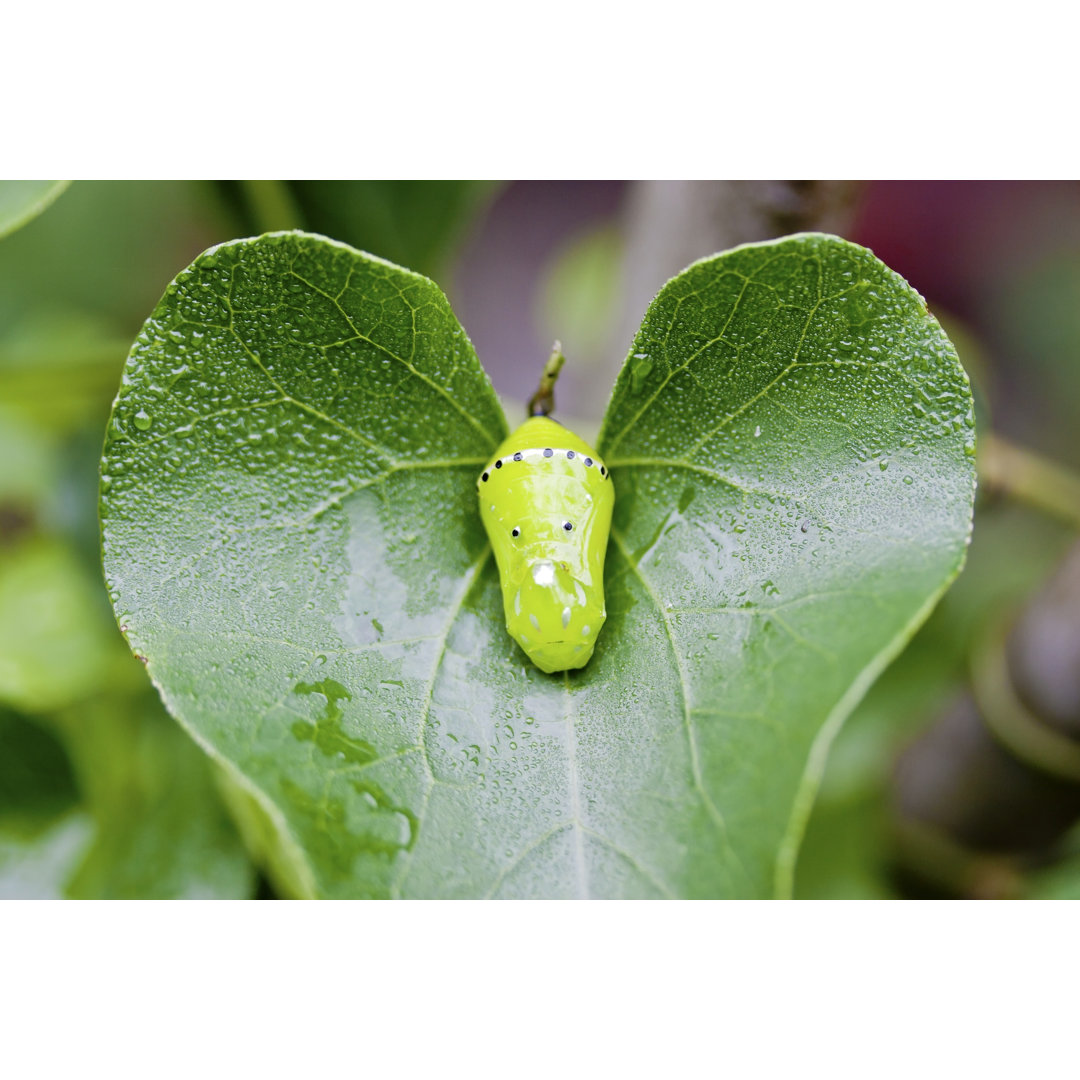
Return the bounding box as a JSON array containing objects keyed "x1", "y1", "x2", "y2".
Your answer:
[{"x1": 476, "y1": 346, "x2": 615, "y2": 673}]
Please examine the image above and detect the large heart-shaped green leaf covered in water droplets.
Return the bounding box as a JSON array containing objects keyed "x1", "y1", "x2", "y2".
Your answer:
[{"x1": 102, "y1": 233, "x2": 973, "y2": 896}]
